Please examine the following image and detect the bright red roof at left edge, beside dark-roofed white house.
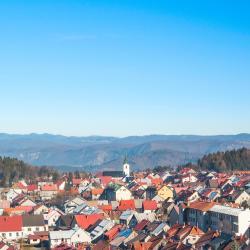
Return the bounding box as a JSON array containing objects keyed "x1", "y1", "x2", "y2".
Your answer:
[{"x1": 0, "y1": 216, "x2": 23, "y2": 232}]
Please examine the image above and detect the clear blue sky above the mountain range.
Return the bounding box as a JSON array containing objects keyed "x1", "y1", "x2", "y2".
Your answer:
[{"x1": 0, "y1": 0, "x2": 250, "y2": 136}]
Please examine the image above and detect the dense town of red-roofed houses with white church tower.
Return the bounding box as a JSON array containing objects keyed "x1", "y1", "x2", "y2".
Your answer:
[{"x1": 0, "y1": 159, "x2": 250, "y2": 250}]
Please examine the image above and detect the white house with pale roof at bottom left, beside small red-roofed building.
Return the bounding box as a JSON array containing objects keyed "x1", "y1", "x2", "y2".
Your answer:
[{"x1": 49, "y1": 227, "x2": 91, "y2": 248}]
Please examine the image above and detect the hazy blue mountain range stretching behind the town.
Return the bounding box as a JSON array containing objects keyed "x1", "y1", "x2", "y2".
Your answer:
[{"x1": 0, "y1": 133, "x2": 250, "y2": 171}]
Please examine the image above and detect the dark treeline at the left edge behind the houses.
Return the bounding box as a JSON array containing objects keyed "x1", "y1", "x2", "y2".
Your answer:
[{"x1": 0, "y1": 157, "x2": 59, "y2": 187}]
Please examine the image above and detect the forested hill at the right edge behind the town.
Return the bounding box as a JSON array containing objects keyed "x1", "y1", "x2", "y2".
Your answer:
[{"x1": 198, "y1": 148, "x2": 250, "y2": 172}]
